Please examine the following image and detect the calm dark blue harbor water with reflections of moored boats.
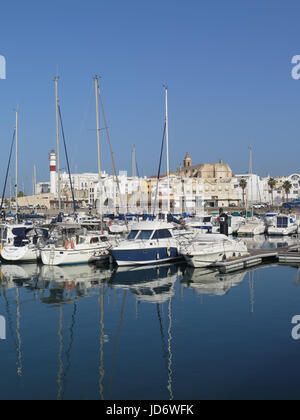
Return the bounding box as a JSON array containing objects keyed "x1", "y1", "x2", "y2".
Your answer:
[{"x1": 0, "y1": 236, "x2": 300, "y2": 400}]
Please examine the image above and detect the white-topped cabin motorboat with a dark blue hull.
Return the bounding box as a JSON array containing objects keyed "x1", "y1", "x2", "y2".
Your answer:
[{"x1": 111, "y1": 221, "x2": 181, "y2": 266}]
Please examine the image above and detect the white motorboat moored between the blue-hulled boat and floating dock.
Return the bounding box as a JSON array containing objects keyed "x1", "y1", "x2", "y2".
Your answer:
[{"x1": 180, "y1": 234, "x2": 249, "y2": 267}]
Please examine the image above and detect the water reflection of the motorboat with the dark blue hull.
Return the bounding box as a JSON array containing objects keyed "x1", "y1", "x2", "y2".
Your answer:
[{"x1": 109, "y1": 264, "x2": 180, "y2": 303}]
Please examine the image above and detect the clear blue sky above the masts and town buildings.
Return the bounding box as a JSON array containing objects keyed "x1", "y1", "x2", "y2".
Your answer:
[{"x1": 0, "y1": 0, "x2": 300, "y2": 192}]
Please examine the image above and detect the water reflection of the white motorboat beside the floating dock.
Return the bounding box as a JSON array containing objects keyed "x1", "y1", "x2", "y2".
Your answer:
[{"x1": 181, "y1": 267, "x2": 247, "y2": 296}]
